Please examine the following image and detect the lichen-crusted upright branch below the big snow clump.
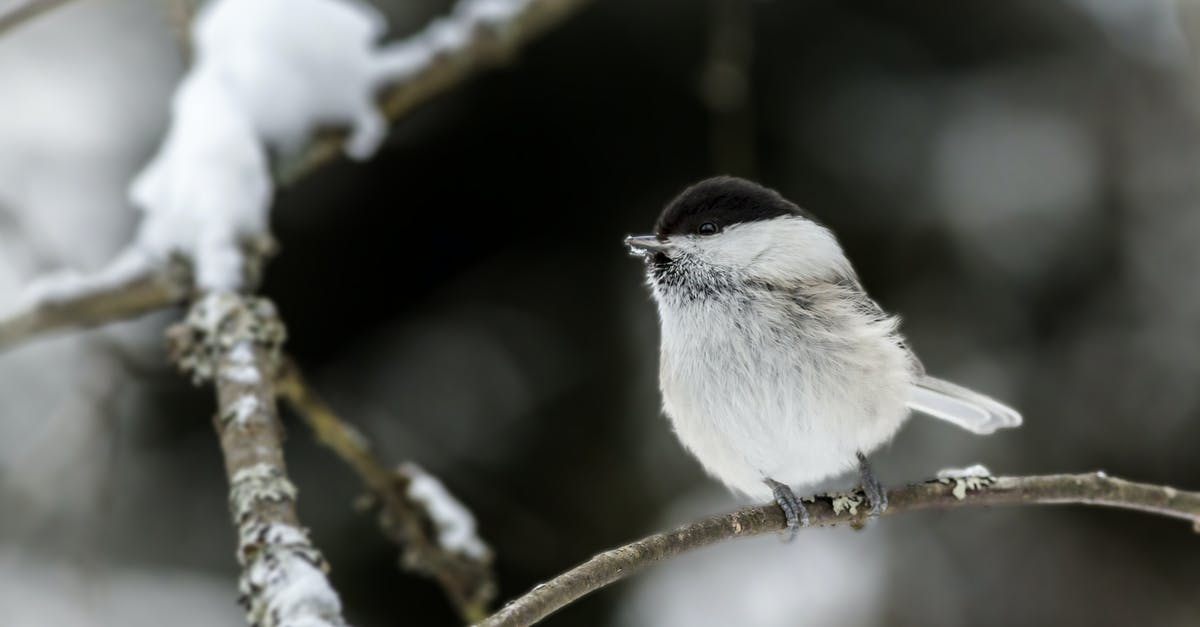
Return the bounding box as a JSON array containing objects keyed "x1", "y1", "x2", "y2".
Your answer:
[{"x1": 168, "y1": 293, "x2": 346, "y2": 627}]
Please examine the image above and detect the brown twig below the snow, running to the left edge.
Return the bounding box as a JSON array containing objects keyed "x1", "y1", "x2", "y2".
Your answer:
[{"x1": 0, "y1": 255, "x2": 191, "y2": 350}]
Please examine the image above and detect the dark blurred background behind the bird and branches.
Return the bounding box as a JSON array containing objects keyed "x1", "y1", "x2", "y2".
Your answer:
[{"x1": 0, "y1": 0, "x2": 1200, "y2": 627}]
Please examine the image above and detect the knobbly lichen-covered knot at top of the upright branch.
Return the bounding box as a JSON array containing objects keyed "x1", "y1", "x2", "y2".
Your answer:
[{"x1": 167, "y1": 292, "x2": 287, "y2": 384}]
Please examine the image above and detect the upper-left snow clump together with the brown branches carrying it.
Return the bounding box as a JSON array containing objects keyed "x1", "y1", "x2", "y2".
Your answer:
[{"x1": 0, "y1": 0, "x2": 586, "y2": 348}]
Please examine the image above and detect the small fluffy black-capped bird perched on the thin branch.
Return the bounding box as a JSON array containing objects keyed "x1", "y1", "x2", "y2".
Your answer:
[{"x1": 625, "y1": 177, "x2": 1021, "y2": 531}]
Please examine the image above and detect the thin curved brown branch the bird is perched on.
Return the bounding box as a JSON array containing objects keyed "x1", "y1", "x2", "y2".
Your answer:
[{"x1": 476, "y1": 472, "x2": 1200, "y2": 627}]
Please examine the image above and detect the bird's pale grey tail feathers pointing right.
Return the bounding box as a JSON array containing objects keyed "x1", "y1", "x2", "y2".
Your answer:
[{"x1": 908, "y1": 375, "x2": 1021, "y2": 435}]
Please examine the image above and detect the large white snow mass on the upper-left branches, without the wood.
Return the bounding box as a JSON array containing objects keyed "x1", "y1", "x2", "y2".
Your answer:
[{"x1": 4, "y1": 0, "x2": 540, "y2": 295}]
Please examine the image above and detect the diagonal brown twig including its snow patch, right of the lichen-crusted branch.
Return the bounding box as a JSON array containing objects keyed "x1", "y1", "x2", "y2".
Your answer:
[{"x1": 276, "y1": 362, "x2": 496, "y2": 622}]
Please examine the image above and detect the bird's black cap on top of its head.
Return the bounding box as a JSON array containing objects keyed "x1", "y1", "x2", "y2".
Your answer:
[{"x1": 654, "y1": 177, "x2": 816, "y2": 239}]
